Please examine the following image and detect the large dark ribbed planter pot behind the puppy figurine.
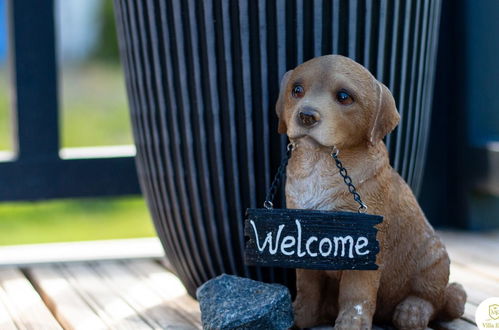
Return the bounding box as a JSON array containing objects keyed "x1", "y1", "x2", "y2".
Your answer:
[{"x1": 115, "y1": 0, "x2": 440, "y2": 294}]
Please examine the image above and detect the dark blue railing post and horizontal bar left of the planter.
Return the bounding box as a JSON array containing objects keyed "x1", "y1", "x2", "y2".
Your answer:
[{"x1": 0, "y1": 0, "x2": 139, "y2": 200}]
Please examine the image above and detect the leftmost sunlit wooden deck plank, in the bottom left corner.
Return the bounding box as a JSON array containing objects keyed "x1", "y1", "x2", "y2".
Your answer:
[{"x1": 0, "y1": 268, "x2": 62, "y2": 329}]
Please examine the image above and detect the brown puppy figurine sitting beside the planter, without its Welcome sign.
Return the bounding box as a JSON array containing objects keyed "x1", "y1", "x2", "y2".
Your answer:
[{"x1": 276, "y1": 55, "x2": 466, "y2": 330}]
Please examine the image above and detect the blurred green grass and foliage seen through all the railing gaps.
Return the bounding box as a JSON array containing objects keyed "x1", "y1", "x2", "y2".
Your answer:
[{"x1": 0, "y1": 0, "x2": 155, "y2": 245}]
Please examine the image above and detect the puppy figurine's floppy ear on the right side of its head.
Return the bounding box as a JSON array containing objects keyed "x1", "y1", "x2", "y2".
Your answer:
[{"x1": 369, "y1": 81, "x2": 400, "y2": 145}]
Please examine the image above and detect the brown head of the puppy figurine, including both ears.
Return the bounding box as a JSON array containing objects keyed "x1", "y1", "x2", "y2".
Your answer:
[{"x1": 276, "y1": 55, "x2": 400, "y2": 149}]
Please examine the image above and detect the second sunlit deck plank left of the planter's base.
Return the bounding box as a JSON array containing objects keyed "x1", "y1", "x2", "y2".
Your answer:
[{"x1": 92, "y1": 261, "x2": 199, "y2": 329}]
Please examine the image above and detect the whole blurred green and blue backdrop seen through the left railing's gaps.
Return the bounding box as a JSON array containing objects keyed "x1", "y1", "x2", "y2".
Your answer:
[{"x1": 0, "y1": 0, "x2": 155, "y2": 245}]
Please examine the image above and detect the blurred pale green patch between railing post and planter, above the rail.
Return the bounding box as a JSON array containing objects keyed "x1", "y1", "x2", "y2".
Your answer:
[{"x1": 60, "y1": 62, "x2": 133, "y2": 148}]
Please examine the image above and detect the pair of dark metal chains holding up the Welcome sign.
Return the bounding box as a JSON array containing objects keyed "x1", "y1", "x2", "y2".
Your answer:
[{"x1": 263, "y1": 143, "x2": 367, "y2": 213}]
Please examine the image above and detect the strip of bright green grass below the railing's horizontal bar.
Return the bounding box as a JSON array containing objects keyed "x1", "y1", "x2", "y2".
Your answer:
[{"x1": 0, "y1": 197, "x2": 155, "y2": 245}]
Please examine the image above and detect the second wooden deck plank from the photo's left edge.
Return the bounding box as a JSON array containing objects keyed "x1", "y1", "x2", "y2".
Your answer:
[{"x1": 28, "y1": 265, "x2": 107, "y2": 330}]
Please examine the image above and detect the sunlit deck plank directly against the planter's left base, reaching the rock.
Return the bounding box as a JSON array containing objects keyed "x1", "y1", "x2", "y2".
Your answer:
[{"x1": 125, "y1": 260, "x2": 201, "y2": 327}]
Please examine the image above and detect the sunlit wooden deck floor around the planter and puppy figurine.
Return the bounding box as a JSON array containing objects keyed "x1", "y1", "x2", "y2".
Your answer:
[{"x1": 0, "y1": 232, "x2": 499, "y2": 330}]
